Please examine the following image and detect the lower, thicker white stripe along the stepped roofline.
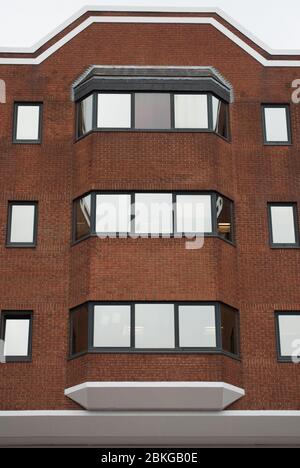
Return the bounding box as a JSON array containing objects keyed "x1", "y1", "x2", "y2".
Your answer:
[{"x1": 0, "y1": 13, "x2": 300, "y2": 67}]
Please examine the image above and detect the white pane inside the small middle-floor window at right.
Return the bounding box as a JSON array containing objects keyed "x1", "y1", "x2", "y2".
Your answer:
[{"x1": 271, "y1": 206, "x2": 296, "y2": 244}]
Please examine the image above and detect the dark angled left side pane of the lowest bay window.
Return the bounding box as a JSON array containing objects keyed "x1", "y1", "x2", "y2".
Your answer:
[{"x1": 71, "y1": 305, "x2": 88, "y2": 355}]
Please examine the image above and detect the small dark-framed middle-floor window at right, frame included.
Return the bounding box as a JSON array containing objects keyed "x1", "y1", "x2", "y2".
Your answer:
[{"x1": 268, "y1": 203, "x2": 298, "y2": 247}]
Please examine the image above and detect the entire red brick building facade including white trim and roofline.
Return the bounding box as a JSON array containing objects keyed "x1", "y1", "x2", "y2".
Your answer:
[{"x1": 0, "y1": 10, "x2": 300, "y2": 445}]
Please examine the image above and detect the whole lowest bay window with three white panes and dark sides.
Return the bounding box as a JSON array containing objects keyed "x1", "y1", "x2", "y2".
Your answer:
[{"x1": 70, "y1": 302, "x2": 239, "y2": 356}]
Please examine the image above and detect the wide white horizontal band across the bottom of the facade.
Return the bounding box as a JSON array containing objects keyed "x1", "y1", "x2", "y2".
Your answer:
[{"x1": 0, "y1": 411, "x2": 300, "y2": 447}]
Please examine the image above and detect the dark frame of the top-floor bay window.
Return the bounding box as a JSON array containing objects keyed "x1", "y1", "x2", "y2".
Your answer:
[{"x1": 76, "y1": 89, "x2": 231, "y2": 142}]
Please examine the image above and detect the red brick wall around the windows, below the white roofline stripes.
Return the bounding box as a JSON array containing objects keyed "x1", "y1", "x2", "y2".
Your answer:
[{"x1": 0, "y1": 13, "x2": 300, "y2": 410}]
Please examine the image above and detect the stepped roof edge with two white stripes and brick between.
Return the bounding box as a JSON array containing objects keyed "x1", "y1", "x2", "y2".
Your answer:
[{"x1": 0, "y1": 5, "x2": 300, "y2": 67}]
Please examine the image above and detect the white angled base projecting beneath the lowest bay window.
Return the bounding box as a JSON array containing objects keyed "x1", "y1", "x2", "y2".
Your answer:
[{"x1": 65, "y1": 382, "x2": 245, "y2": 411}]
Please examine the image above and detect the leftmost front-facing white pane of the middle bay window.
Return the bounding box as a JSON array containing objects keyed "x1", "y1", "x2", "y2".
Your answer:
[{"x1": 96, "y1": 195, "x2": 131, "y2": 234}]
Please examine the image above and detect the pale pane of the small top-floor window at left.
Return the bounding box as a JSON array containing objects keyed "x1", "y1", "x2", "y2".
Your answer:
[{"x1": 16, "y1": 105, "x2": 40, "y2": 140}]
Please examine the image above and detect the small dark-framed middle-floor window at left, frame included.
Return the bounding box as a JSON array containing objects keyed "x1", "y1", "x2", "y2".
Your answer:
[{"x1": 7, "y1": 202, "x2": 37, "y2": 247}]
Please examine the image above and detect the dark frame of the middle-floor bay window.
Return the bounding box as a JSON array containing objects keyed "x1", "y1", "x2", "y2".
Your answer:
[{"x1": 71, "y1": 189, "x2": 235, "y2": 246}]
